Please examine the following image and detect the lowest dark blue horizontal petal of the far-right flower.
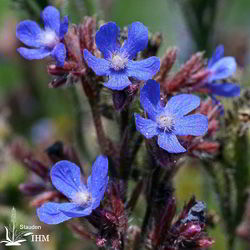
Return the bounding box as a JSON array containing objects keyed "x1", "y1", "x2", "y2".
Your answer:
[{"x1": 205, "y1": 83, "x2": 240, "y2": 97}]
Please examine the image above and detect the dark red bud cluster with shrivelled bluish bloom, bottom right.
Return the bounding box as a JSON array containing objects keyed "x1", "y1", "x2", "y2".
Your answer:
[{"x1": 150, "y1": 197, "x2": 213, "y2": 250}]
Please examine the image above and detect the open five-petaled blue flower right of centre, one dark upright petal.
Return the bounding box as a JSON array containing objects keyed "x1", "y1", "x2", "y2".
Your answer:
[{"x1": 135, "y1": 80, "x2": 208, "y2": 153}]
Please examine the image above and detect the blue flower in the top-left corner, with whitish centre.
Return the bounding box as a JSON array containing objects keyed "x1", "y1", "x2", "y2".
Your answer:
[{"x1": 16, "y1": 6, "x2": 68, "y2": 66}]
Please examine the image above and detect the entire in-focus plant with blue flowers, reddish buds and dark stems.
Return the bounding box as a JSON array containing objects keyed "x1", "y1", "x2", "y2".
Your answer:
[{"x1": 12, "y1": 6, "x2": 245, "y2": 250}]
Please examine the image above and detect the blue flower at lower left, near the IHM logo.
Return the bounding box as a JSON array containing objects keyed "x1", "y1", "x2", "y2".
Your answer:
[{"x1": 37, "y1": 156, "x2": 108, "y2": 224}]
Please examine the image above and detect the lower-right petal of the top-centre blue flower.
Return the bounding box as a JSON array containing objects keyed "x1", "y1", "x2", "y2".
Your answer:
[{"x1": 127, "y1": 56, "x2": 160, "y2": 81}]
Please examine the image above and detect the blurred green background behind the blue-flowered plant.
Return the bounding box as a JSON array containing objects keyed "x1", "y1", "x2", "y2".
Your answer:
[{"x1": 0, "y1": 0, "x2": 250, "y2": 250}]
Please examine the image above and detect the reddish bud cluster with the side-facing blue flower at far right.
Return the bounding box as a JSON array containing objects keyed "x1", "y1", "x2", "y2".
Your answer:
[{"x1": 156, "y1": 45, "x2": 240, "y2": 97}]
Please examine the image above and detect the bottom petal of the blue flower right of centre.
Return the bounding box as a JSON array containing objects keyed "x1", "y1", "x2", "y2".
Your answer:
[{"x1": 157, "y1": 133, "x2": 186, "y2": 154}]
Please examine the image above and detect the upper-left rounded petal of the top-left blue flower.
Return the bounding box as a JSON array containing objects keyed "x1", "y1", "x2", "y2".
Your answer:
[{"x1": 16, "y1": 20, "x2": 43, "y2": 48}]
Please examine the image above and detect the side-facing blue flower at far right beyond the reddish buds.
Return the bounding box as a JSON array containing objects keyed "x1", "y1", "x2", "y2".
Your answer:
[{"x1": 205, "y1": 45, "x2": 240, "y2": 97}]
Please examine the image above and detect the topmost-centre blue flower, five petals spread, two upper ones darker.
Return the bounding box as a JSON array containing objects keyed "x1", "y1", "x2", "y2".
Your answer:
[{"x1": 84, "y1": 22, "x2": 160, "y2": 90}]
